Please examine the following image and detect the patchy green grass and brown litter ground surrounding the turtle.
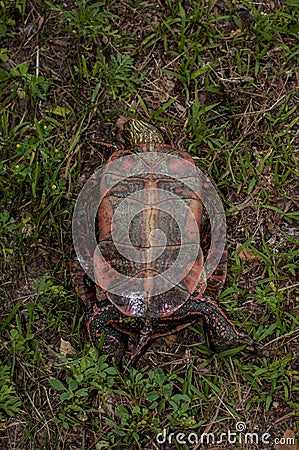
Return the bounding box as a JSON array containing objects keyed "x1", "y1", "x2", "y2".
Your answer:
[{"x1": 0, "y1": 0, "x2": 299, "y2": 450}]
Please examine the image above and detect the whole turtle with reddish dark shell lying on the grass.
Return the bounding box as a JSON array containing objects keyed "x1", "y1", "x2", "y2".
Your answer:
[{"x1": 71, "y1": 119, "x2": 255, "y2": 365}]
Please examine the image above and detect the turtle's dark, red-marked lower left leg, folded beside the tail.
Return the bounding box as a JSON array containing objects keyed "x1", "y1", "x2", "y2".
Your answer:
[{"x1": 86, "y1": 301, "x2": 128, "y2": 364}]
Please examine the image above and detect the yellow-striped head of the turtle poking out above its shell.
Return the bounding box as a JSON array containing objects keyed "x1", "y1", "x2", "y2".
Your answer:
[{"x1": 123, "y1": 119, "x2": 165, "y2": 145}]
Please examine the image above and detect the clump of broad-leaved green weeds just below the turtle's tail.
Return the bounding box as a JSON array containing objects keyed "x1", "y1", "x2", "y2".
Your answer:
[{"x1": 49, "y1": 349, "x2": 204, "y2": 448}]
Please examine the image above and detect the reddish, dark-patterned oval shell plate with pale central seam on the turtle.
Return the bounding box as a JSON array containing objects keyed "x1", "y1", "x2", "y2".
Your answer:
[{"x1": 94, "y1": 142, "x2": 206, "y2": 318}]
